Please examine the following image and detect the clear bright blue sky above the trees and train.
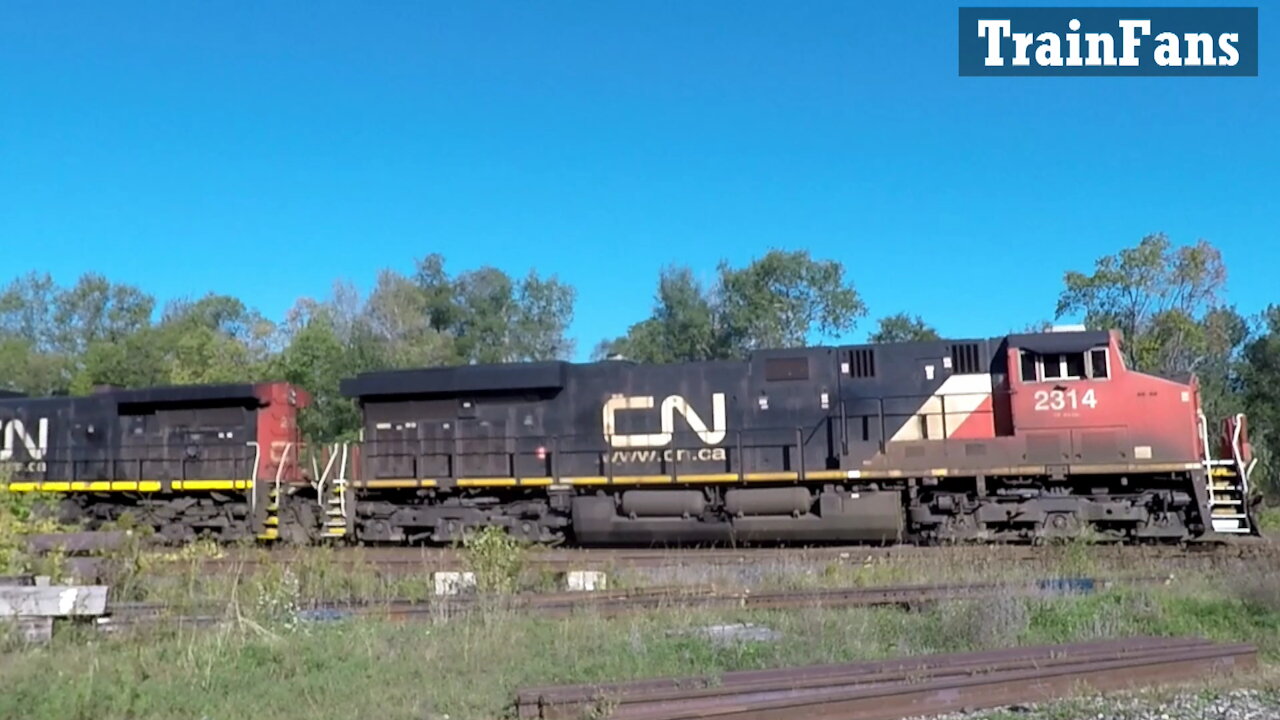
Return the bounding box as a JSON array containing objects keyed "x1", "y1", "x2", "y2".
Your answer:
[{"x1": 0, "y1": 0, "x2": 1280, "y2": 355}]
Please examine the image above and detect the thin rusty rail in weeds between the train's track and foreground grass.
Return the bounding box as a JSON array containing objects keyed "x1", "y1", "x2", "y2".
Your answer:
[{"x1": 97, "y1": 577, "x2": 1169, "y2": 626}]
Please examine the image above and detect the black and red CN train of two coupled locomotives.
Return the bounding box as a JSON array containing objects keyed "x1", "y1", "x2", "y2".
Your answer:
[{"x1": 0, "y1": 331, "x2": 1257, "y2": 546}]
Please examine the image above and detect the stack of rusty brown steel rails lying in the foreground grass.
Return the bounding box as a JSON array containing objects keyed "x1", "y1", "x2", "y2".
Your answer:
[{"x1": 515, "y1": 638, "x2": 1257, "y2": 720}]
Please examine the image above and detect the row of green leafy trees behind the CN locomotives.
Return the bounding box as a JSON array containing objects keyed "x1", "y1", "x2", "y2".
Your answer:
[{"x1": 0, "y1": 234, "x2": 1280, "y2": 491}]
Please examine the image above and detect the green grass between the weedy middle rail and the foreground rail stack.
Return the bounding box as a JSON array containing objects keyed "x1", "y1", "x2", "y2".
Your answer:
[{"x1": 0, "y1": 580, "x2": 1280, "y2": 720}]
